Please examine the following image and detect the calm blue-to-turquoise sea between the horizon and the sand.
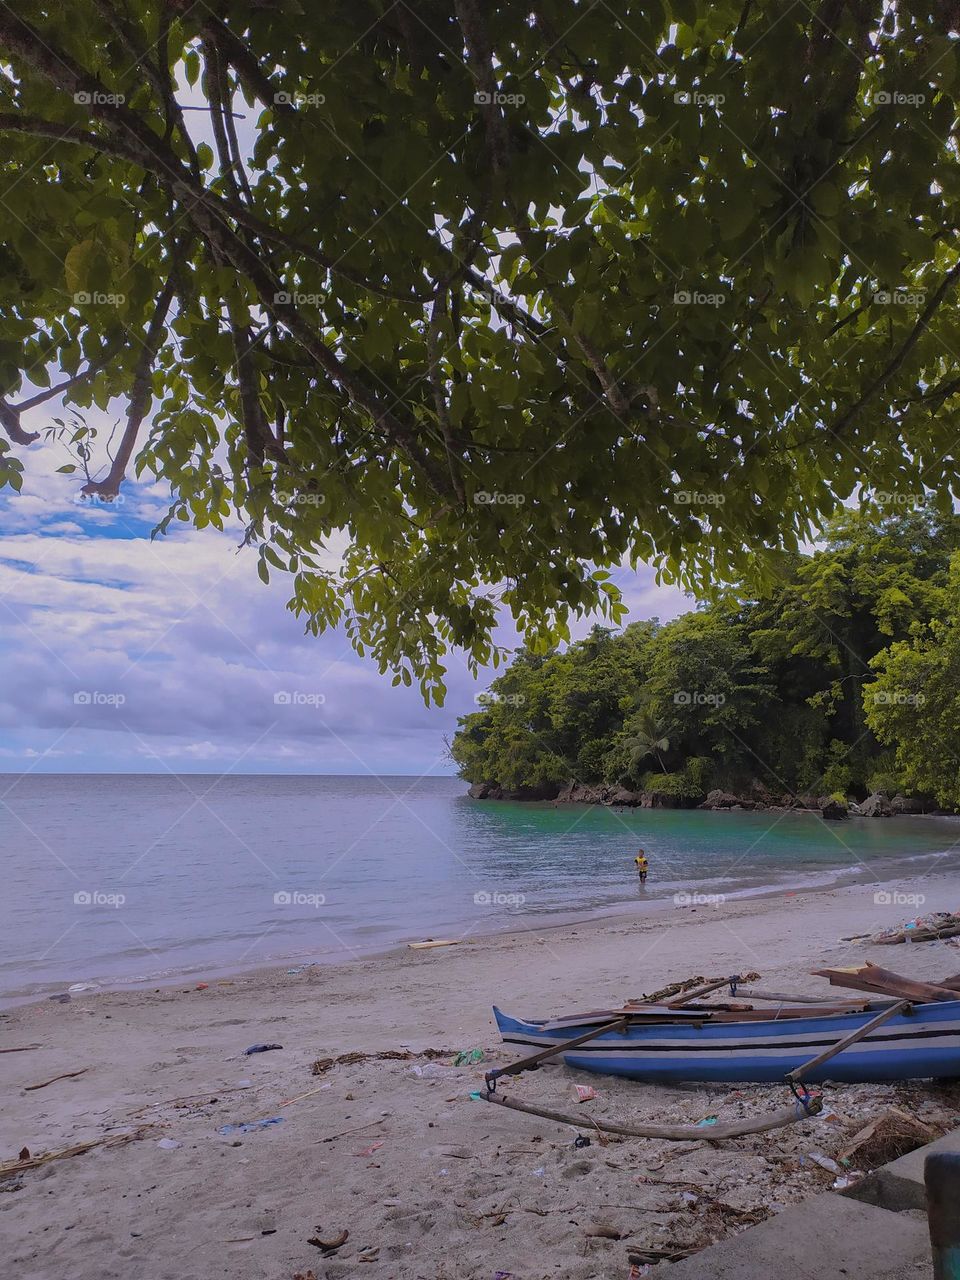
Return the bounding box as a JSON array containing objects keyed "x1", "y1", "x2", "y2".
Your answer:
[{"x1": 0, "y1": 774, "x2": 960, "y2": 1004}]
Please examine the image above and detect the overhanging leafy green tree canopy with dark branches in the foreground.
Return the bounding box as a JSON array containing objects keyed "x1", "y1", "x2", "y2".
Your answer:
[{"x1": 0, "y1": 0, "x2": 960, "y2": 696}]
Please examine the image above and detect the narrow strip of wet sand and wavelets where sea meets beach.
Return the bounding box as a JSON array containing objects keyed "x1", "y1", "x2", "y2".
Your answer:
[{"x1": 9, "y1": 851, "x2": 960, "y2": 1015}]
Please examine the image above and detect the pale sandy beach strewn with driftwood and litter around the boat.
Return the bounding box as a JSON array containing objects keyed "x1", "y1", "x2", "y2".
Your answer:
[{"x1": 0, "y1": 873, "x2": 960, "y2": 1280}]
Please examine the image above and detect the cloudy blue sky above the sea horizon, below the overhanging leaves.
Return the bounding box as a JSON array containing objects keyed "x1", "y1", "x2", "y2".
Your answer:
[{"x1": 0, "y1": 404, "x2": 694, "y2": 774}]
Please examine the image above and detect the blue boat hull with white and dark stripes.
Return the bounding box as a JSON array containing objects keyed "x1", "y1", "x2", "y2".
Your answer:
[{"x1": 493, "y1": 1000, "x2": 960, "y2": 1084}]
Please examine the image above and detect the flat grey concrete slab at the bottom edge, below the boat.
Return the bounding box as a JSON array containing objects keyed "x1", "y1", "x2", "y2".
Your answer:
[{"x1": 657, "y1": 1192, "x2": 931, "y2": 1280}]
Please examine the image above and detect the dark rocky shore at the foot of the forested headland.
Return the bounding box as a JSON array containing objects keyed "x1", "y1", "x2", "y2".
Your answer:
[{"x1": 467, "y1": 782, "x2": 943, "y2": 822}]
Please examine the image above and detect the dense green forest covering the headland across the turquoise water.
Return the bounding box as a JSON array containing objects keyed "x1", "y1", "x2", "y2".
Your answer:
[{"x1": 451, "y1": 506, "x2": 960, "y2": 817}]
